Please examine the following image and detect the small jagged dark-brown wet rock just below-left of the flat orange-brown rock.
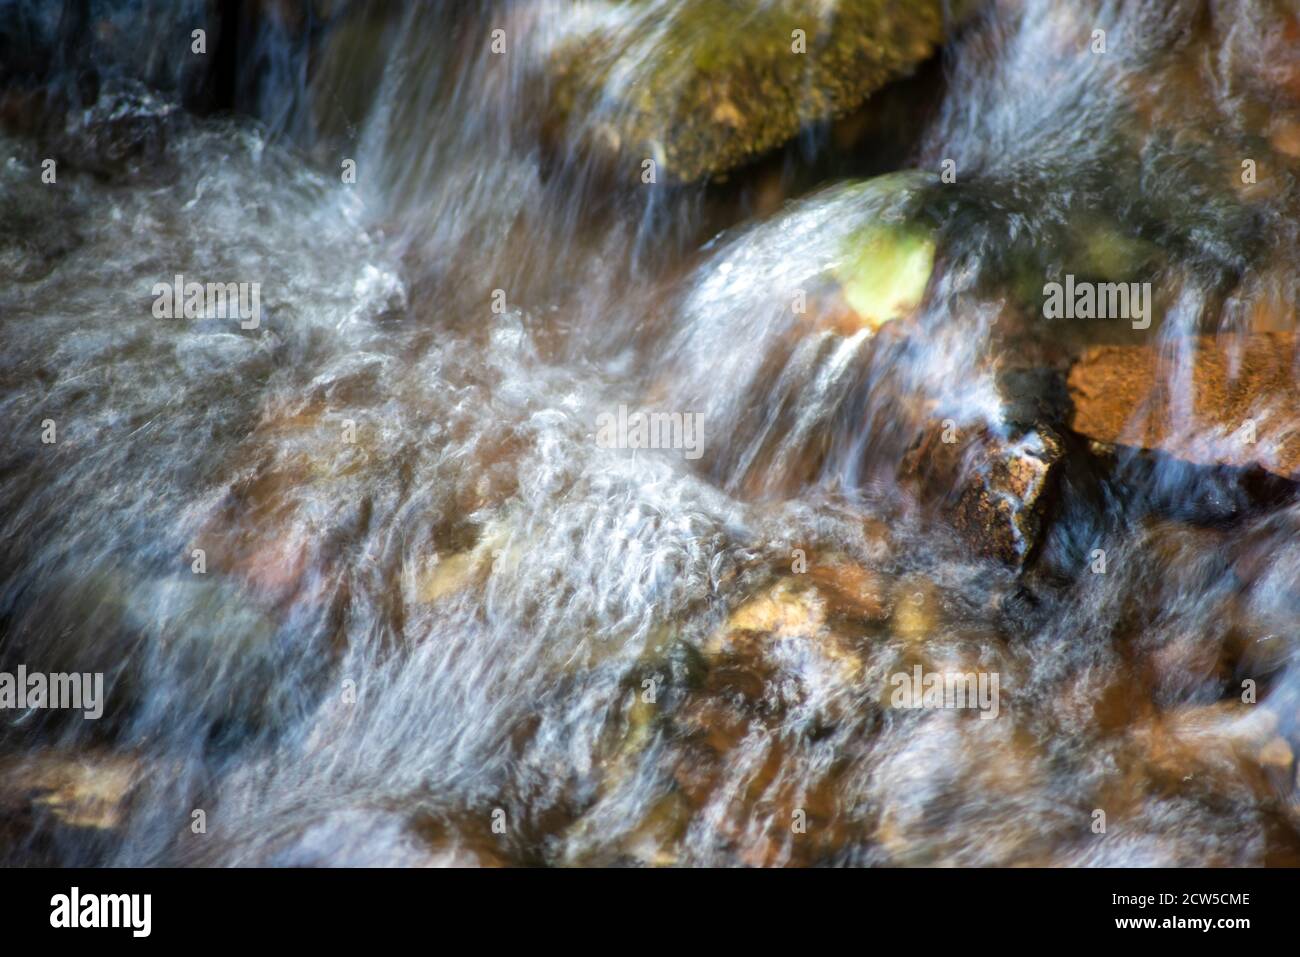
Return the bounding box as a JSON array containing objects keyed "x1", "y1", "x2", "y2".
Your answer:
[{"x1": 902, "y1": 425, "x2": 1062, "y2": 566}]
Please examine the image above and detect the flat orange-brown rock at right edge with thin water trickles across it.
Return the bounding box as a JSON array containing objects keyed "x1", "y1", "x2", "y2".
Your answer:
[{"x1": 1067, "y1": 332, "x2": 1300, "y2": 480}]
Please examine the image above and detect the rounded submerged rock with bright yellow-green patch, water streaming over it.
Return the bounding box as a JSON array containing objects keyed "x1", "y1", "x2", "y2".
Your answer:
[{"x1": 663, "y1": 170, "x2": 943, "y2": 498}]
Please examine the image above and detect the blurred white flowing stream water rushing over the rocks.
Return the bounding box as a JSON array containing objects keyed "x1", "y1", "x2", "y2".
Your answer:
[{"x1": 0, "y1": 0, "x2": 1300, "y2": 865}]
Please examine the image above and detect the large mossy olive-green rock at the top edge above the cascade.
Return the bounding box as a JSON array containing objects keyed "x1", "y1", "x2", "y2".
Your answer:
[{"x1": 549, "y1": 0, "x2": 966, "y2": 182}]
